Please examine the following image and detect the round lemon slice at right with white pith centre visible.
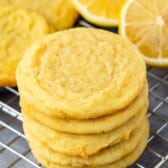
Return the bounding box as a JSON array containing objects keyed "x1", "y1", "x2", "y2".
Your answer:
[{"x1": 119, "y1": 0, "x2": 168, "y2": 67}]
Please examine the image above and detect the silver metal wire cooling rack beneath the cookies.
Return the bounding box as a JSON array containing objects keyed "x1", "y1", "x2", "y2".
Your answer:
[{"x1": 0, "y1": 19, "x2": 168, "y2": 168}]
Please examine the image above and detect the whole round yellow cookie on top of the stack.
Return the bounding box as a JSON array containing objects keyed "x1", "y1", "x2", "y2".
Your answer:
[{"x1": 17, "y1": 28, "x2": 146, "y2": 119}]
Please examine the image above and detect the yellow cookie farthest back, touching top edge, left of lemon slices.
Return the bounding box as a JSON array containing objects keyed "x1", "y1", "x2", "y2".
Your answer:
[{"x1": 0, "y1": 0, "x2": 78, "y2": 30}]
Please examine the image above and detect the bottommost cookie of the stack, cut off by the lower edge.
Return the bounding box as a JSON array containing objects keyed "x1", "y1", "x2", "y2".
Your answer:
[{"x1": 25, "y1": 119, "x2": 149, "y2": 168}]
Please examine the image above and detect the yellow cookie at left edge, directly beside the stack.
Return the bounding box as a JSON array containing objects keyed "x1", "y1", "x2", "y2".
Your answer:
[{"x1": 0, "y1": 5, "x2": 49, "y2": 86}]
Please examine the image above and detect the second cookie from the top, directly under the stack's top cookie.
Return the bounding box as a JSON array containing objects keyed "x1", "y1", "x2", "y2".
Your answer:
[{"x1": 20, "y1": 82, "x2": 148, "y2": 134}]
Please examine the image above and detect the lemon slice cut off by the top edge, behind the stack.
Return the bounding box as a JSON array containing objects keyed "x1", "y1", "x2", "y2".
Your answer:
[{"x1": 71, "y1": 0, "x2": 125, "y2": 26}]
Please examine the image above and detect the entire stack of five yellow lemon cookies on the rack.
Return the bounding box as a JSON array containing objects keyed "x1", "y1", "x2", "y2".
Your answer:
[{"x1": 17, "y1": 28, "x2": 149, "y2": 168}]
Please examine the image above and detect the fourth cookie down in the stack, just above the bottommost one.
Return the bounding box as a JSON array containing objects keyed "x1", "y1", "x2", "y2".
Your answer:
[{"x1": 24, "y1": 118, "x2": 148, "y2": 167}]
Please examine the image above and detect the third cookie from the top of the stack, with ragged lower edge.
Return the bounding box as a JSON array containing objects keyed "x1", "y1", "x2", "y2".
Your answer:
[{"x1": 23, "y1": 101, "x2": 148, "y2": 158}]
